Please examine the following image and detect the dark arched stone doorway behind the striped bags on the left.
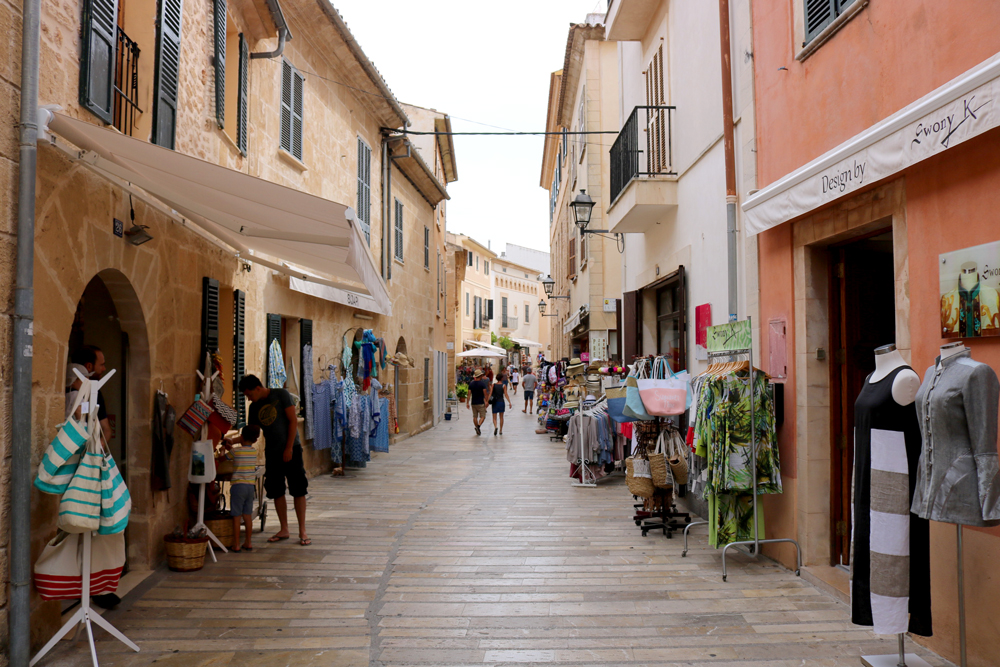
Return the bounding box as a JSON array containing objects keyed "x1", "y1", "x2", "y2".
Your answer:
[{"x1": 68, "y1": 269, "x2": 153, "y2": 569}]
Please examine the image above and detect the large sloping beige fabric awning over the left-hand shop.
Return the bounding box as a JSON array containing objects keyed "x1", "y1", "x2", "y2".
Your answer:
[{"x1": 40, "y1": 109, "x2": 392, "y2": 314}]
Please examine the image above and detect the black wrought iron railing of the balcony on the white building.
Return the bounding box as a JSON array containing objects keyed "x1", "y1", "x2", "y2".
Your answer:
[{"x1": 610, "y1": 106, "x2": 677, "y2": 202}]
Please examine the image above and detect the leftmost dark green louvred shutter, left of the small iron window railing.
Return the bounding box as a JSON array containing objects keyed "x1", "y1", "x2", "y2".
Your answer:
[{"x1": 80, "y1": 0, "x2": 118, "y2": 124}]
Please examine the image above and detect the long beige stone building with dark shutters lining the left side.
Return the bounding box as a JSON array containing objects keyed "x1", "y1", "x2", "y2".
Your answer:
[{"x1": 0, "y1": 0, "x2": 456, "y2": 654}]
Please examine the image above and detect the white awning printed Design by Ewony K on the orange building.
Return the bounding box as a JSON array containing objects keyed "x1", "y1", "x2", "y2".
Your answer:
[{"x1": 743, "y1": 54, "x2": 1000, "y2": 235}]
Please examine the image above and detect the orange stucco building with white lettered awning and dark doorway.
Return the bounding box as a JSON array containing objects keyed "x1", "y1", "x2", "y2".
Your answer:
[{"x1": 743, "y1": 0, "x2": 1000, "y2": 667}]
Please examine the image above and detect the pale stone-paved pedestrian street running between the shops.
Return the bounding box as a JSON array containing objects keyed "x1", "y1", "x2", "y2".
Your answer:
[{"x1": 42, "y1": 404, "x2": 948, "y2": 667}]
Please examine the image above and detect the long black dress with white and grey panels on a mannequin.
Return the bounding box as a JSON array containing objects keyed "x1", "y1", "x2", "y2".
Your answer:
[{"x1": 851, "y1": 366, "x2": 931, "y2": 637}]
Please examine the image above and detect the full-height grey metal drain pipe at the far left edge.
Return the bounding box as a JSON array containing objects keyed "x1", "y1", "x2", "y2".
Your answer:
[{"x1": 7, "y1": 0, "x2": 41, "y2": 667}]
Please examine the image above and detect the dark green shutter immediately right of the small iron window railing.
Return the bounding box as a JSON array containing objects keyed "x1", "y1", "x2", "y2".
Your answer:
[{"x1": 153, "y1": 0, "x2": 183, "y2": 149}]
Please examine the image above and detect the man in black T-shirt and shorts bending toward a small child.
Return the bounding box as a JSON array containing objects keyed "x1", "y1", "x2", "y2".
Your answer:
[{"x1": 231, "y1": 375, "x2": 312, "y2": 547}]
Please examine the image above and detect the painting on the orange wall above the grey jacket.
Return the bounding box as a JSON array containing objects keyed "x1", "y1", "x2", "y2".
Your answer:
[{"x1": 939, "y1": 241, "x2": 1000, "y2": 338}]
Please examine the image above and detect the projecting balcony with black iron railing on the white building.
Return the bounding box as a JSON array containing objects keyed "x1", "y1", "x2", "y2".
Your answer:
[{"x1": 608, "y1": 106, "x2": 677, "y2": 233}]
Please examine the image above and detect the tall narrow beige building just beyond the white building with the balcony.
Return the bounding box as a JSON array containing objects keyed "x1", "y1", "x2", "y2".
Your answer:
[{"x1": 540, "y1": 14, "x2": 622, "y2": 360}]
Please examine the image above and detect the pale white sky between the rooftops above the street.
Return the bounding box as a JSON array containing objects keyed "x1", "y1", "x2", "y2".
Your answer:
[{"x1": 331, "y1": 0, "x2": 607, "y2": 253}]
